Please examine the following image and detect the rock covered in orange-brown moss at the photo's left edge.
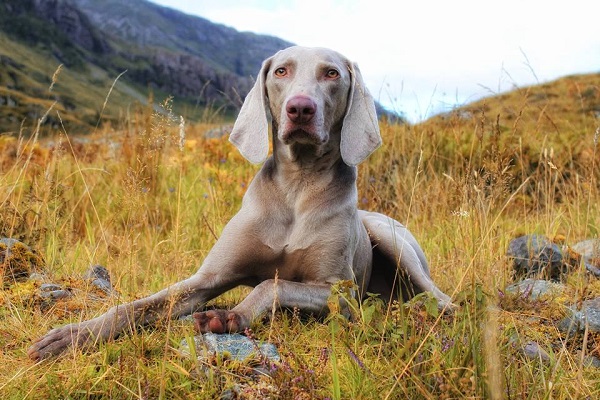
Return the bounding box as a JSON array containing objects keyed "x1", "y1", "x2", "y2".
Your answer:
[{"x1": 0, "y1": 238, "x2": 44, "y2": 285}]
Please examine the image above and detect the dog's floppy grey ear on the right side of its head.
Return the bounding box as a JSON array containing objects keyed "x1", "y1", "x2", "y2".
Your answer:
[{"x1": 340, "y1": 63, "x2": 381, "y2": 166}]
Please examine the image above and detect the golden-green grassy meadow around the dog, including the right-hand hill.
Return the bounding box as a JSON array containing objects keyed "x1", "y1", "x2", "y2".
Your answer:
[{"x1": 0, "y1": 75, "x2": 600, "y2": 399}]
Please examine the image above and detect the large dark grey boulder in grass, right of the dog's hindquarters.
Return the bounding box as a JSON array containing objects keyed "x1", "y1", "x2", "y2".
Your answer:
[{"x1": 507, "y1": 235, "x2": 570, "y2": 280}]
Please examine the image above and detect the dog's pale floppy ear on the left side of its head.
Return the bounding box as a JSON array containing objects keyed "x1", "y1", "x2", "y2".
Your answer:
[{"x1": 229, "y1": 58, "x2": 271, "y2": 164}]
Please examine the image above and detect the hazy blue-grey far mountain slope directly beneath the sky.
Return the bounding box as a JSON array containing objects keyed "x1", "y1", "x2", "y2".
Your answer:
[{"x1": 74, "y1": 0, "x2": 291, "y2": 76}]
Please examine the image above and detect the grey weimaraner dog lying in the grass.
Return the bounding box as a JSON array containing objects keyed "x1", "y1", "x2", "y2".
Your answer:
[{"x1": 29, "y1": 47, "x2": 451, "y2": 360}]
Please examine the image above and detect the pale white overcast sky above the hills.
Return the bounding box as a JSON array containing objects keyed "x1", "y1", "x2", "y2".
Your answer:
[{"x1": 152, "y1": 0, "x2": 600, "y2": 122}]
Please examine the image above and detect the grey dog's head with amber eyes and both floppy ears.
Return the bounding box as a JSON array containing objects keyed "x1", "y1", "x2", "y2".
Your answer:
[{"x1": 229, "y1": 46, "x2": 381, "y2": 166}]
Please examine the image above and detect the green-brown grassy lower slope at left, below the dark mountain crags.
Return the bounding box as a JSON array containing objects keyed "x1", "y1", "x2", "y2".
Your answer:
[{"x1": 0, "y1": 33, "x2": 148, "y2": 134}]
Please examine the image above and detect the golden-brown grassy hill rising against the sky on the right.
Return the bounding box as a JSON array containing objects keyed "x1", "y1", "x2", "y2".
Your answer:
[{"x1": 414, "y1": 73, "x2": 600, "y2": 189}]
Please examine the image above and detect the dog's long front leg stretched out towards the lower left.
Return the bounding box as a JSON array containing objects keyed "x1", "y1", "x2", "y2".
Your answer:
[{"x1": 28, "y1": 214, "x2": 270, "y2": 361}]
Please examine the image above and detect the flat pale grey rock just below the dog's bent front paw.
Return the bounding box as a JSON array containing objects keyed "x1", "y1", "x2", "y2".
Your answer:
[{"x1": 181, "y1": 333, "x2": 281, "y2": 362}]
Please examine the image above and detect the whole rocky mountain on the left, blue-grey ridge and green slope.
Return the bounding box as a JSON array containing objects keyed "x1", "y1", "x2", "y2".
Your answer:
[{"x1": 0, "y1": 0, "x2": 291, "y2": 132}]
